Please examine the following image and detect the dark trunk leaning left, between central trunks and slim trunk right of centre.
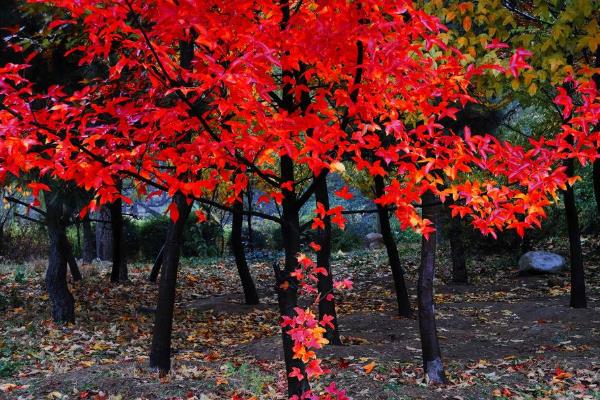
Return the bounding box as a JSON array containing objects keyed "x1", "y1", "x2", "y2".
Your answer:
[{"x1": 374, "y1": 175, "x2": 412, "y2": 317}]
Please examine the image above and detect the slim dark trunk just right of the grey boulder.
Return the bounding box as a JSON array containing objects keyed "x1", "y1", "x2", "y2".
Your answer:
[{"x1": 563, "y1": 159, "x2": 587, "y2": 308}]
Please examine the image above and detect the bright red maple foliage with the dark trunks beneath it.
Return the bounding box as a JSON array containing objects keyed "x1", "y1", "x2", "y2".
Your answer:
[{"x1": 0, "y1": 0, "x2": 598, "y2": 398}]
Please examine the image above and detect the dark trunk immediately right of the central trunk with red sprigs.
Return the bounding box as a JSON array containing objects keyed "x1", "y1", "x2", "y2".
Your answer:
[{"x1": 313, "y1": 174, "x2": 342, "y2": 346}]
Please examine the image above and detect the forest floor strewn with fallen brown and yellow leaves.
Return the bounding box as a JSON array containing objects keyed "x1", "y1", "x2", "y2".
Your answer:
[{"x1": 0, "y1": 238, "x2": 600, "y2": 400}]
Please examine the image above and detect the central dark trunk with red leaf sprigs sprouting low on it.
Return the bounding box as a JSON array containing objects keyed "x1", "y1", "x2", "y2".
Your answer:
[{"x1": 275, "y1": 156, "x2": 310, "y2": 397}]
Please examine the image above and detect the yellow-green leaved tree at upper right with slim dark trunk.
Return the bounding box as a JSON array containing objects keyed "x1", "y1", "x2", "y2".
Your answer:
[{"x1": 424, "y1": 0, "x2": 600, "y2": 308}]
